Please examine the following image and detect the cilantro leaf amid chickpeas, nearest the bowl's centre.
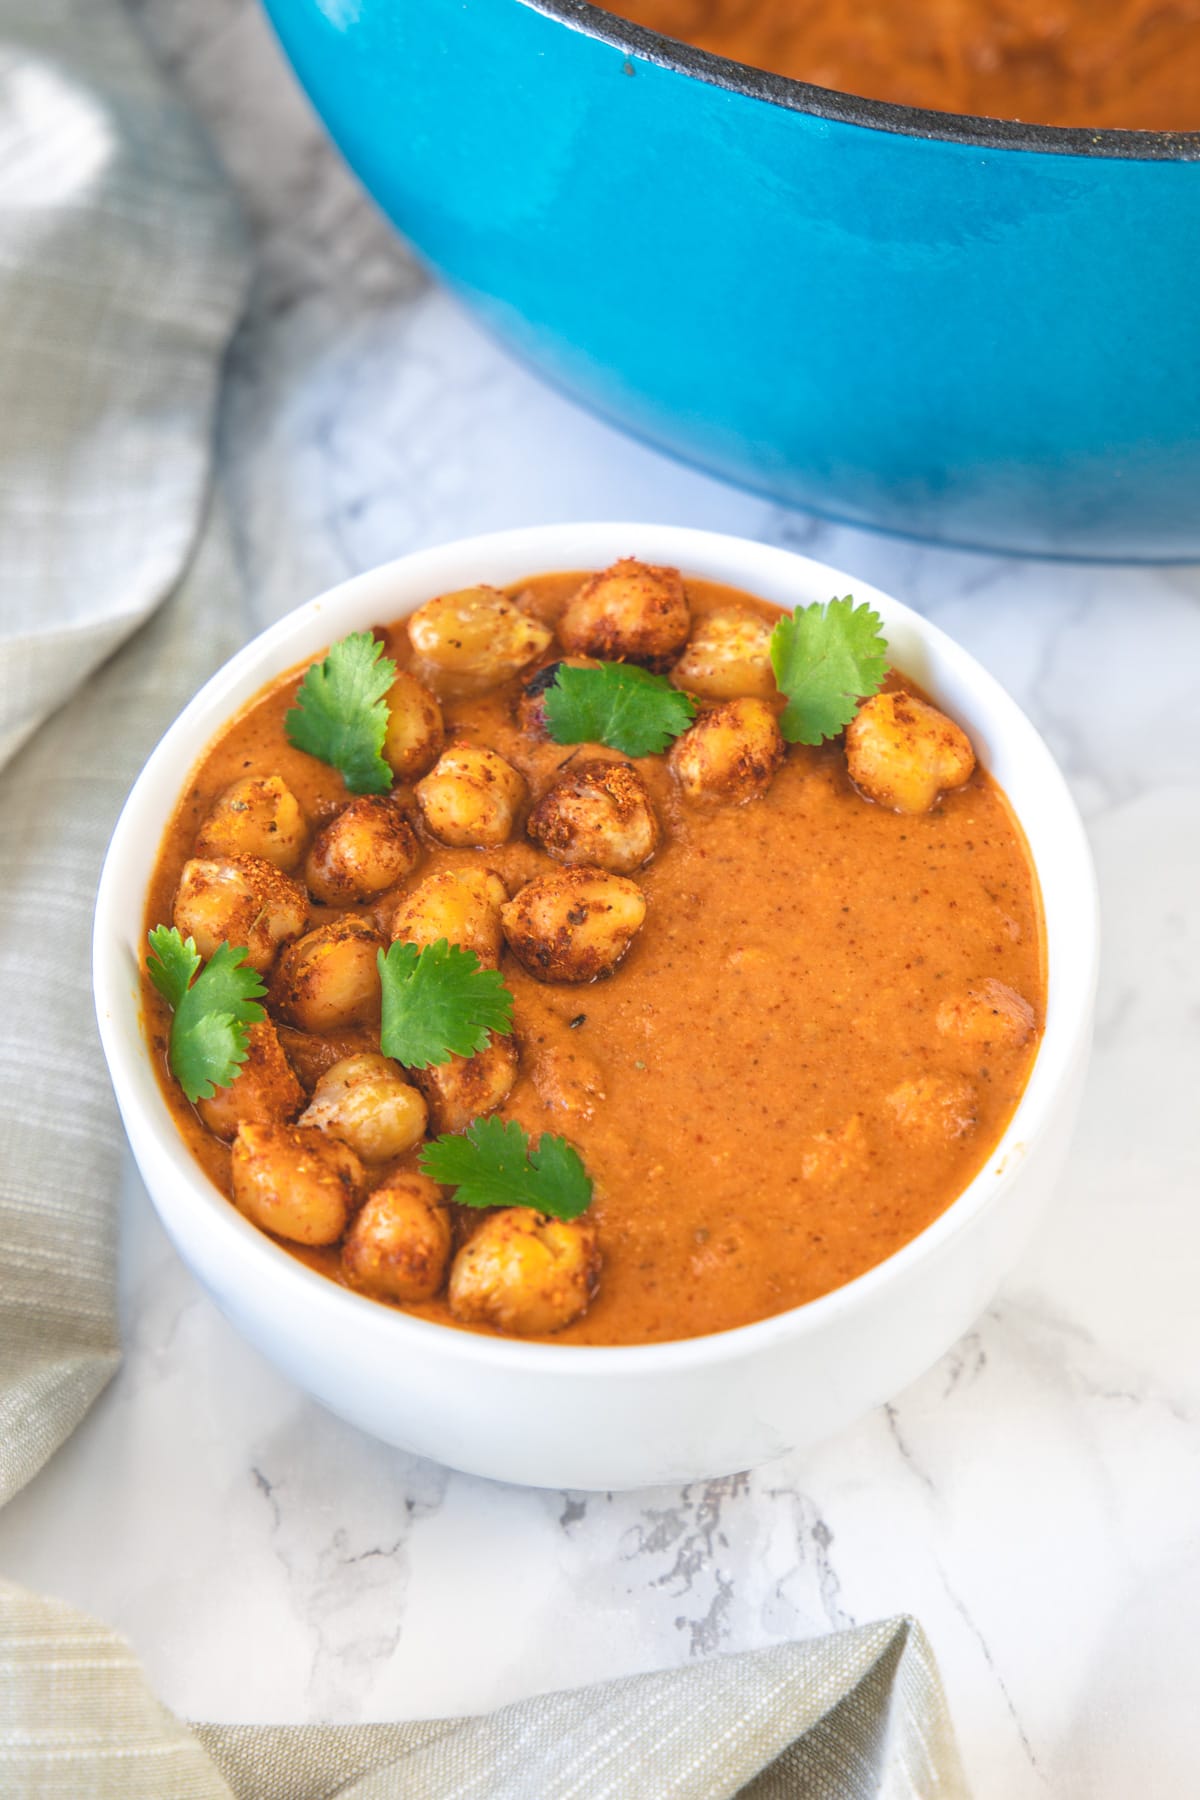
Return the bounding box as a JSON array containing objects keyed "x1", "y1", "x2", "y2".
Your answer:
[{"x1": 380, "y1": 938, "x2": 513, "y2": 1069}]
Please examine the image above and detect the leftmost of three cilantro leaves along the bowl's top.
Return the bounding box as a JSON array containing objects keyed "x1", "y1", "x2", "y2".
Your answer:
[{"x1": 284, "y1": 632, "x2": 396, "y2": 794}]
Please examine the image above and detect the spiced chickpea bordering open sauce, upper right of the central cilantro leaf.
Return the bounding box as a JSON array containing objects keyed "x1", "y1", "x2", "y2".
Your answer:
[{"x1": 500, "y1": 868, "x2": 646, "y2": 981}]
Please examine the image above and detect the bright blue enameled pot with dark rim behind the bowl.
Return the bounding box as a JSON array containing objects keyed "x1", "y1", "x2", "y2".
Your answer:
[{"x1": 266, "y1": 0, "x2": 1200, "y2": 558}]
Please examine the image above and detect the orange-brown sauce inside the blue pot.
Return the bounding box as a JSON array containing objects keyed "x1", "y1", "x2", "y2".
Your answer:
[{"x1": 606, "y1": 0, "x2": 1200, "y2": 131}]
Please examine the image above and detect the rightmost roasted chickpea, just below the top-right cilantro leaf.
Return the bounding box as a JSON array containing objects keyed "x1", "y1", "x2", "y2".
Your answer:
[{"x1": 846, "y1": 693, "x2": 975, "y2": 812}]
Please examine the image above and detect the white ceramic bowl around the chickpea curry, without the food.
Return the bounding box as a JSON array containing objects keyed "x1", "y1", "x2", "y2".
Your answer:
[{"x1": 94, "y1": 526, "x2": 1097, "y2": 1489}]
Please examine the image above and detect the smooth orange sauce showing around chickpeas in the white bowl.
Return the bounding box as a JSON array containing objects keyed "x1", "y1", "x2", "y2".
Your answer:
[{"x1": 144, "y1": 574, "x2": 1045, "y2": 1345}]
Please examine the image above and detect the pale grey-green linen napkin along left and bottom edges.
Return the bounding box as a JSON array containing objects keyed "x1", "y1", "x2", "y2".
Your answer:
[{"x1": 0, "y1": 0, "x2": 964, "y2": 1800}]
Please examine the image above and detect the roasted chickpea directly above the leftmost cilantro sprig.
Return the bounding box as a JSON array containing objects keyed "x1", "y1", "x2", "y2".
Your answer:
[{"x1": 173, "y1": 857, "x2": 308, "y2": 974}]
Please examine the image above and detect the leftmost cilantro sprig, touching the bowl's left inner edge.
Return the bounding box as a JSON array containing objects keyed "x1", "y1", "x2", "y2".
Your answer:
[{"x1": 146, "y1": 925, "x2": 266, "y2": 1105}]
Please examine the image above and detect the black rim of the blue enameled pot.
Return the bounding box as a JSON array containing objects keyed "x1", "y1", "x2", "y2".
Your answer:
[{"x1": 518, "y1": 0, "x2": 1200, "y2": 162}]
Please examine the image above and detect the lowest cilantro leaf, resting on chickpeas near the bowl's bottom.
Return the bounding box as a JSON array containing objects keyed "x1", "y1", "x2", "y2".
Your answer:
[{"x1": 421, "y1": 1118, "x2": 592, "y2": 1219}]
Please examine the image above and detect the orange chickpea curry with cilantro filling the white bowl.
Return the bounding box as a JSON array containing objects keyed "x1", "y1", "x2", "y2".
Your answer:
[{"x1": 146, "y1": 560, "x2": 1045, "y2": 1345}]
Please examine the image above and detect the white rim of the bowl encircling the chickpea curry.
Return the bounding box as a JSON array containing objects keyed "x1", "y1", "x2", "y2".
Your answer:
[{"x1": 92, "y1": 522, "x2": 1099, "y2": 1381}]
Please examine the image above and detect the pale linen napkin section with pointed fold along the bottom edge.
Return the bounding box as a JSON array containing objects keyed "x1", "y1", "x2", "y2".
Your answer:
[{"x1": 0, "y1": 1584, "x2": 966, "y2": 1800}]
